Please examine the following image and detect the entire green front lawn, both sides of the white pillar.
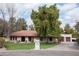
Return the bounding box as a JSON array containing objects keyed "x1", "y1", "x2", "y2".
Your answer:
[{"x1": 5, "y1": 42, "x2": 56, "y2": 50}]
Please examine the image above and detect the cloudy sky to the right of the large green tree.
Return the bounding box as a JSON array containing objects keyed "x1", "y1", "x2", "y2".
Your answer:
[{"x1": 57, "y1": 4, "x2": 79, "y2": 27}]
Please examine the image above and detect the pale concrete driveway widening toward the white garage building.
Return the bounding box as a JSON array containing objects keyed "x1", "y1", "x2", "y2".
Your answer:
[{"x1": 46, "y1": 42, "x2": 79, "y2": 51}]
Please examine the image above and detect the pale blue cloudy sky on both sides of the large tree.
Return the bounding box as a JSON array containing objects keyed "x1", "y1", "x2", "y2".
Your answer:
[{"x1": 0, "y1": 3, "x2": 79, "y2": 28}]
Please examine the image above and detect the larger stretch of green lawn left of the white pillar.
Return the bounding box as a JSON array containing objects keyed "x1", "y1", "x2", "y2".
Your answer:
[{"x1": 5, "y1": 42, "x2": 34, "y2": 50}]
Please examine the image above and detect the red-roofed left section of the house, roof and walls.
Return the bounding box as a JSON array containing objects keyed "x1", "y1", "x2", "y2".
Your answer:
[{"x1": 10, "y1": 30, "x2": 37, "y2": 43}]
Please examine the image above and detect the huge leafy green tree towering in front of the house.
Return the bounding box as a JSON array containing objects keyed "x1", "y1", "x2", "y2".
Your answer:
[{"x1": 31, "y1": 4, "x2": 61, "y2": 37}]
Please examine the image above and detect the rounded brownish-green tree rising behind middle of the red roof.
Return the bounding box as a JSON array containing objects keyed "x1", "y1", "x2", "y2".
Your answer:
[{"x1": 16, "y1": 18, "x2": 27, "y2": 31}]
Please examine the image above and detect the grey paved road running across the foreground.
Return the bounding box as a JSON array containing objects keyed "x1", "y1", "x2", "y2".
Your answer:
[{"x1": 0, "y1": 50, "x2": 79, "y2": 56}]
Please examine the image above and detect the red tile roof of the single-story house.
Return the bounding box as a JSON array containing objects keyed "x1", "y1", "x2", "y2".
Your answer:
[{"x1": 10, "y1": 30, "x2": 37, "y2": 36}]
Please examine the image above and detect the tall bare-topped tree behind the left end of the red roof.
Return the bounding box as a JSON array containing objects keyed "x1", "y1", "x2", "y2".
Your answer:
[{"x1": 6, "y1": 4, "x2": 17, "y2": 36}]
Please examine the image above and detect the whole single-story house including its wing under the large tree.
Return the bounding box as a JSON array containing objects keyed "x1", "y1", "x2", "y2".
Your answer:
[{"x1": 10, "y1": 30, "x2": 55, "y2": 43}]
